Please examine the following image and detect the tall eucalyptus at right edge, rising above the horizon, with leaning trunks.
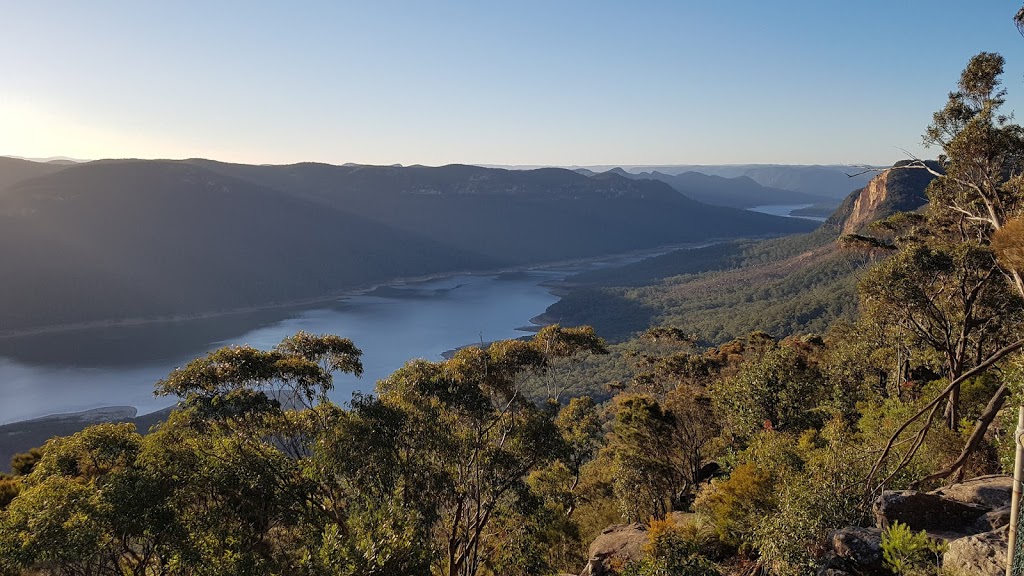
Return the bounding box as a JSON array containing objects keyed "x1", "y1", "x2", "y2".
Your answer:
[{"x1": 868, "y1": 52, "x2": 1024, "y2": 492}]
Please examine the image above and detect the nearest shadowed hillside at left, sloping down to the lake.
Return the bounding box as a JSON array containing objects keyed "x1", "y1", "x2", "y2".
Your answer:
[{"x1": 0, "y1": 162, "x2": 497, "y2": 331}]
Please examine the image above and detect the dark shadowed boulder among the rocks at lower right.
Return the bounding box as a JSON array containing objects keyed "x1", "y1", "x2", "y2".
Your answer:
[{"x1": 874, "y1": 490, "x2": 991, "y2": 539}]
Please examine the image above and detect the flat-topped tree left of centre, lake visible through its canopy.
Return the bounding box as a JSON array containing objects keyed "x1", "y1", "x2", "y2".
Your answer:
[{"x1": 144, "y1": 332, "x2": 370, "y2": 574}]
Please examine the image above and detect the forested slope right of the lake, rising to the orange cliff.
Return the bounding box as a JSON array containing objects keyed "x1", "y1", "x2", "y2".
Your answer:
[{"x1": 543, "y1": 162, "x2": 936, "y2": 343}]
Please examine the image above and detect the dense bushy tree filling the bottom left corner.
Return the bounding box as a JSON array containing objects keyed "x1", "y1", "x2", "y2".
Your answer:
[{"x1": 0, "y1": 424, "x2": 184, "y2": 576}]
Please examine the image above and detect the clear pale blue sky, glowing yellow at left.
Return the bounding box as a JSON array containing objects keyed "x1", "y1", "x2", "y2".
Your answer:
[{"x1": 0, "y1": 0, "x2": 1024, "y2": 165}]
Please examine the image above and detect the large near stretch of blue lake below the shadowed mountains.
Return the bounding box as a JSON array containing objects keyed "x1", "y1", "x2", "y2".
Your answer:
[{"x1": 0, "y1": 243, "x2": 692, "y2": 424}]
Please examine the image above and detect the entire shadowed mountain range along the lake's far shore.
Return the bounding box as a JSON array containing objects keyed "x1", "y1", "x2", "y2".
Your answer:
[{"x1": 0, "y1": 158, "x2": 814, "y2": 334}]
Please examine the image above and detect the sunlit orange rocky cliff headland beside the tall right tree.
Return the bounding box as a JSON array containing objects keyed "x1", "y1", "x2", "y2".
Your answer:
[{"x1": 828, "y1": 162, "x2": 938, "y2": 234}]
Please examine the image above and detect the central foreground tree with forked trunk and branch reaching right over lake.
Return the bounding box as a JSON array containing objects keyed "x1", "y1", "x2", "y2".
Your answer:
[{"x1": 378, "y1": 327, "x2": 604, "y2": 576}]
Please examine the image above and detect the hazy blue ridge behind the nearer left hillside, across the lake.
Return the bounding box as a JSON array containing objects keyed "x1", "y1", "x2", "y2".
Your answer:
[{"x1": 186, "y1": 161, "x2": 815, "y2": 263}]
